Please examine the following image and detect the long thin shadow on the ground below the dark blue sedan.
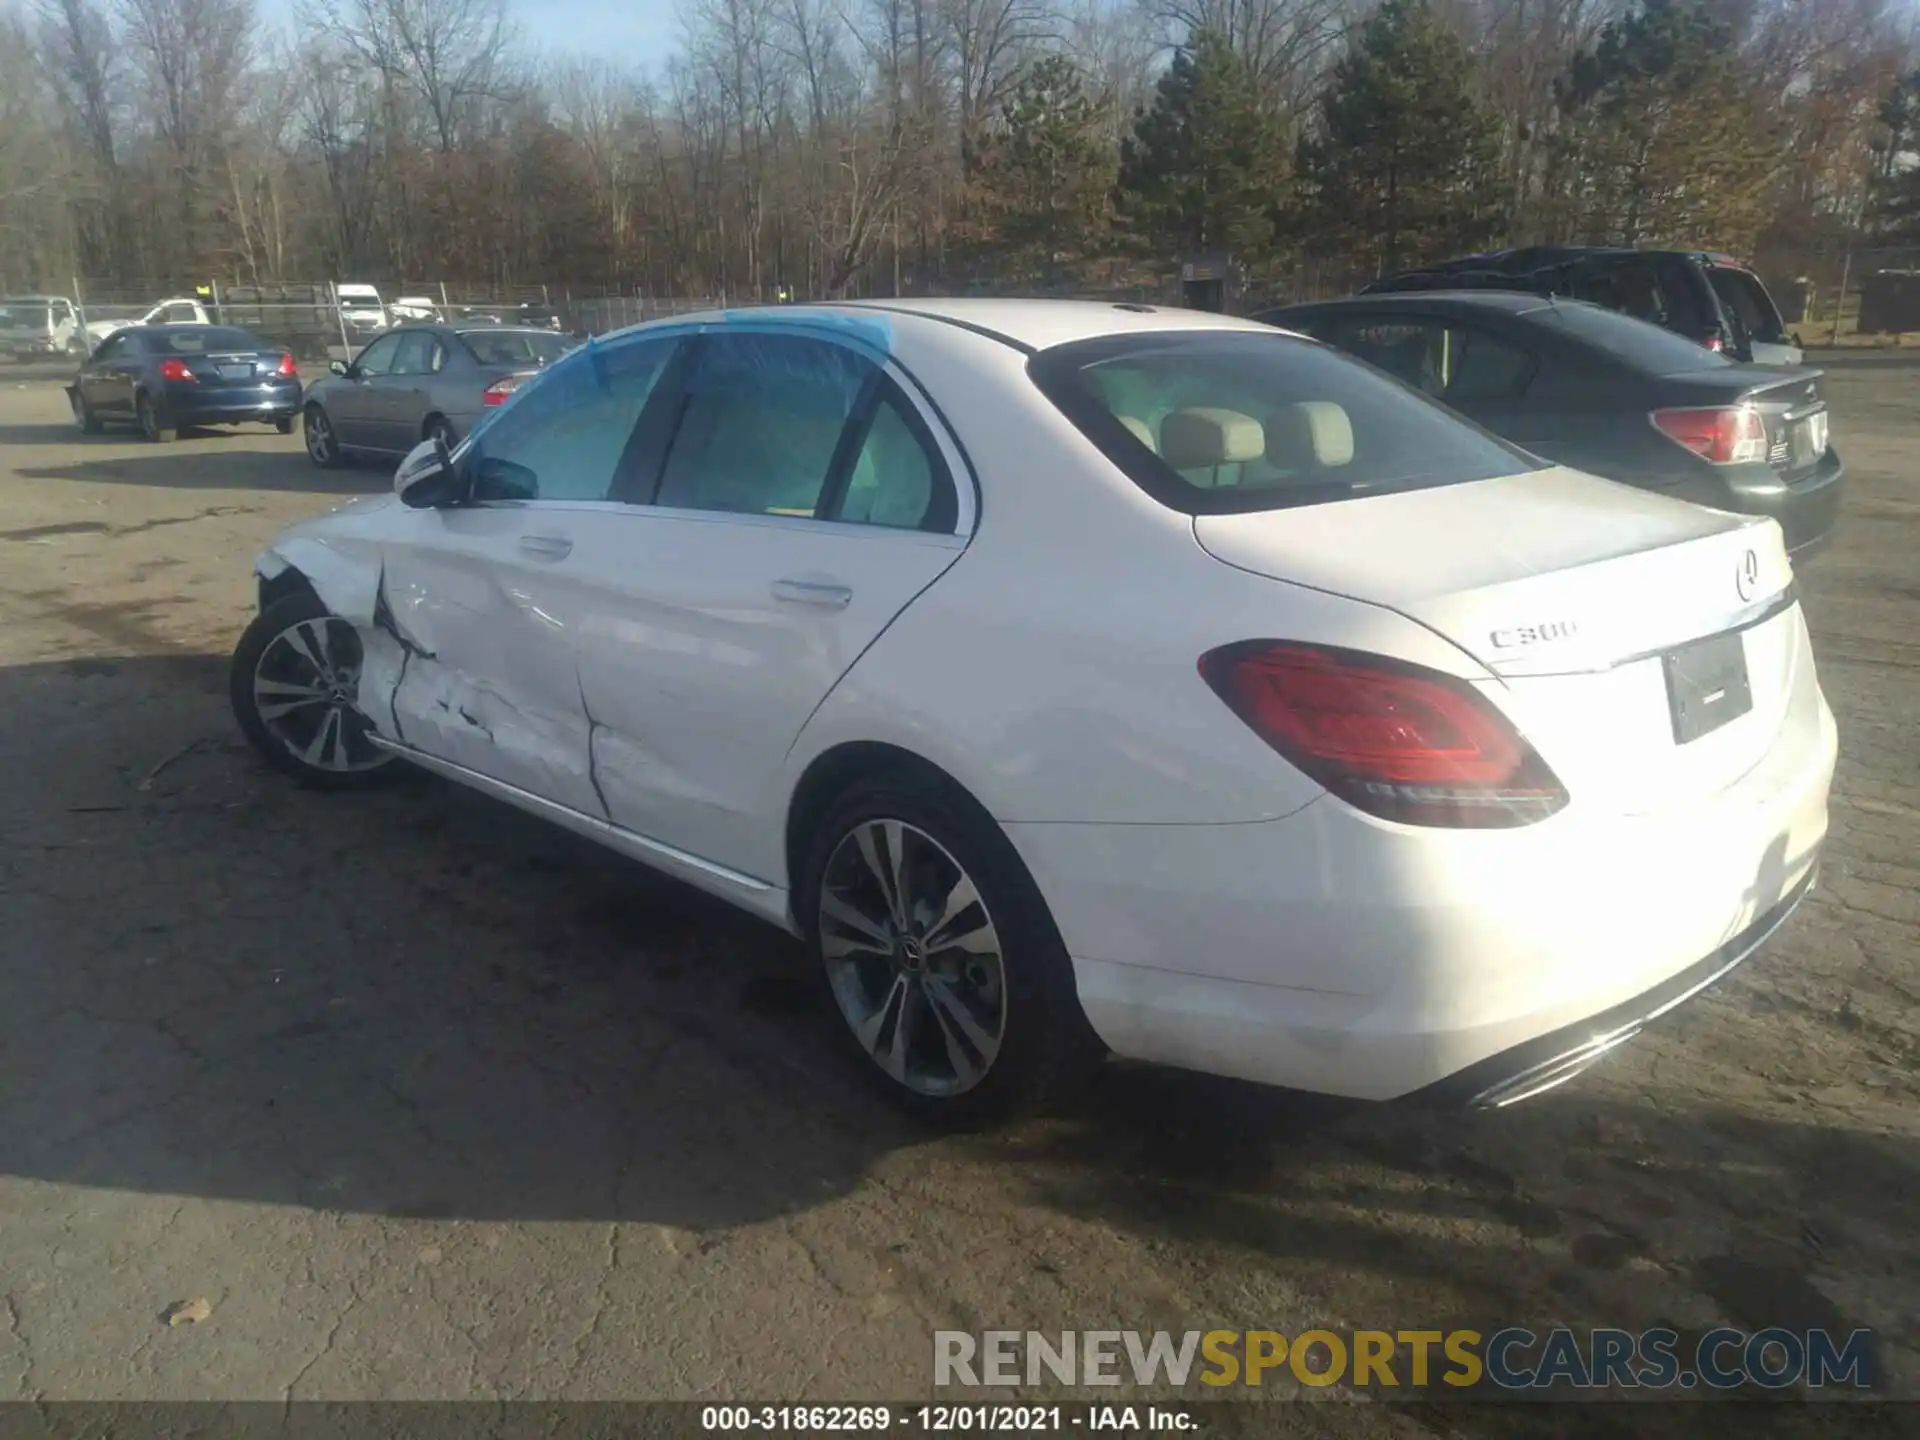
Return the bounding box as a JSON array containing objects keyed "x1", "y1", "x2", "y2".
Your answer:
[{"x1": 11, "y1": 445, "x2": 394, "y2": 495}]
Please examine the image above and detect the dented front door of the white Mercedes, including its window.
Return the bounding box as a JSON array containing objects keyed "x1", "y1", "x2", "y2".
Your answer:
[{"x1": 378, "y1": 340, "x2": 674, "y2": 820}]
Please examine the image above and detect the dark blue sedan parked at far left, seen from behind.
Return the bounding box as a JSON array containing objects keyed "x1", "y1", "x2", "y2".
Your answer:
[{"x1": 67, "y1": 324, "x2": 300, "y2": 440}]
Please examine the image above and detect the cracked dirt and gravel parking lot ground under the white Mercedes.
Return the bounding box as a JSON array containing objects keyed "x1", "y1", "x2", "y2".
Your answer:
[{"x1": 0, "y1": 353, "x2": 1920, "y2": 1436}]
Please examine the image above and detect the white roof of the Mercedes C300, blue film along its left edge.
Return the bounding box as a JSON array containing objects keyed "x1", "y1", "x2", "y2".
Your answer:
[{"x1": 629, "y1": 300, "x2": 1273, "y2": 349}]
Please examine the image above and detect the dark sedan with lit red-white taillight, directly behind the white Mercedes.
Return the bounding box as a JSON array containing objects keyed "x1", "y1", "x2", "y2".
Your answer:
[{"x1": 1260, "y1": 290, "x2": 1845, "y2": 561}]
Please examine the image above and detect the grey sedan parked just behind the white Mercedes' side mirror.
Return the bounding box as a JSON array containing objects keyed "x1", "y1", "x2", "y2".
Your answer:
[{"x1": 301, "y1": 323, "x2": 574, "y2": 467}]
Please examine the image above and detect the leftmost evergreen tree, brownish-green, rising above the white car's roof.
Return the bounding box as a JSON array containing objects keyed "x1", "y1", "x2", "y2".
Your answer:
[{"x1": 977, "y1": 56, "x2": 1116, "y2": 276}]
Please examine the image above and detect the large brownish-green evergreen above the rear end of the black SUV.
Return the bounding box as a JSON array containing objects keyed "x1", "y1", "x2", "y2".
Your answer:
[{"x1": 1553, "y1": 0, "x2": 1774, "y2": 250}]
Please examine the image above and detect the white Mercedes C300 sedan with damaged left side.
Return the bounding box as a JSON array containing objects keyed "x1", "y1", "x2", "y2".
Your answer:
[{"x1": 232, "y1": 301, "x2": 1836, "y2": 1121}]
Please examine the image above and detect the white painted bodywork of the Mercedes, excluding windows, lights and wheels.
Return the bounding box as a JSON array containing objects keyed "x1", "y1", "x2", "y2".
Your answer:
[{"x1": 257, "y1": 301, "x2": 1837, "y2": 1098}]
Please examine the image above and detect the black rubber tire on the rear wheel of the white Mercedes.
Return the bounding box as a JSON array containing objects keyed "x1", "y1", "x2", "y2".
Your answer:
[{"x1": 795, "y1": 770, "x2": 1104, "y2": 1129}]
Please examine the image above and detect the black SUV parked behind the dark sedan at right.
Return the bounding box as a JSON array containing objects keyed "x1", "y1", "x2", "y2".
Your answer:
[{"x1": 1361, "y1": 246, "x2": 1803, "y2": 365}]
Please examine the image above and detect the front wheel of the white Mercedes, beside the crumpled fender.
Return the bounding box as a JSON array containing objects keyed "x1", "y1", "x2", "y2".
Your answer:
[{"x1": 227, "y1": 589, "x2": 405, "y2": 791}]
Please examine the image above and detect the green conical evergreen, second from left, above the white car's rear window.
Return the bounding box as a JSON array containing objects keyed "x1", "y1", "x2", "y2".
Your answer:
[{"x1": 1114, "y1": 31, "x2": 1284, "y2": 259}]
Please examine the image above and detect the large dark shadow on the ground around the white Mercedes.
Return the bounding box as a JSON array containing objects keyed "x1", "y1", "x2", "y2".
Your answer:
[{"x1": 0, "y1": 656, "x2": 1920, "y2": 1413}]
